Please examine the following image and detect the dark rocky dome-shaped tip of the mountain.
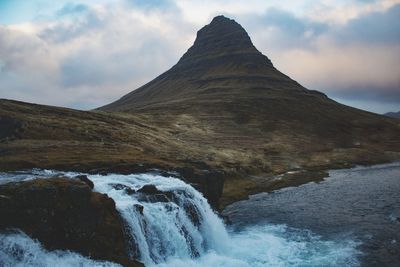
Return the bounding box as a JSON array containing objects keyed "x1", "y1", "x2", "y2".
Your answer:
[{"x1": 181, "y1": 16, "x2": 260, "y2": 61}]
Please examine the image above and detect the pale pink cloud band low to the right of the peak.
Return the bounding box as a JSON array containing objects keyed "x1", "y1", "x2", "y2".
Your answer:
[{"x1": 279, "y1": 43, "x2": 400, "y2": 101}]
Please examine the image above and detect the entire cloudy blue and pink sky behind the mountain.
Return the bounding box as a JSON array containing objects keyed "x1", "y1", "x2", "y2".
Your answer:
[{"x1": 0, "y1": 0, "x2": 400, "y2": 113}]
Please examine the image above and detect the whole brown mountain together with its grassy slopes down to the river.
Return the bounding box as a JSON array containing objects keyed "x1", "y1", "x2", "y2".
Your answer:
[{"x1": 0, "y1": 16, "x2": 400, "y2": 208}]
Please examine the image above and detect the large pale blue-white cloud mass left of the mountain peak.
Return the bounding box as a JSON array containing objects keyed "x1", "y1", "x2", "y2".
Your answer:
[{"x1": 0, "y1": 0, "x2": 195, "y2": 109}]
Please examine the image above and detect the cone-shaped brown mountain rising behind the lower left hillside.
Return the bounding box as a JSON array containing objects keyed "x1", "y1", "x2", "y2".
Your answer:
[{"x1": 100, "y1": 16, "x2": 400, "y2": 194}]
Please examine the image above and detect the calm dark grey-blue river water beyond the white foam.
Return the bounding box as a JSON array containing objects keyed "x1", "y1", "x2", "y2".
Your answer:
[{"x1": 224, "y1": 163, "x2": 400, "y2": 266}]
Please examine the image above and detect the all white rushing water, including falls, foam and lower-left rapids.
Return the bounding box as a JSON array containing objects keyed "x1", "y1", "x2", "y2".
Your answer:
[{"x1": 0, "y1": 171, "x2": 359, "y2": 267}]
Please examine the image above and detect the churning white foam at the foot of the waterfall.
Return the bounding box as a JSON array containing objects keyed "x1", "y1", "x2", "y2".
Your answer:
[{"x1": 155, "y1": 225, "x2": 359, "y2": 267}]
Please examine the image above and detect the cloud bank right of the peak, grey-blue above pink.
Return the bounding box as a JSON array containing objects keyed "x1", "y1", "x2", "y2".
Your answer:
[{"x1": 243, "y1": 5, "x2": 400, "y2": 110}]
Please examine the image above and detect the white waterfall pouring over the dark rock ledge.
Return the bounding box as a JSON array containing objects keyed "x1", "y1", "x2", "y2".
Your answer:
[{"x1": 90, "y1": 174, "x2": 229, "y2": 265}]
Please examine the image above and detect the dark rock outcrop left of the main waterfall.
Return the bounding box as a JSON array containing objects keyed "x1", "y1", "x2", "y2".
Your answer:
[{"x1": 0, "y1": 177, "x2": 143, "y2": 266}]
